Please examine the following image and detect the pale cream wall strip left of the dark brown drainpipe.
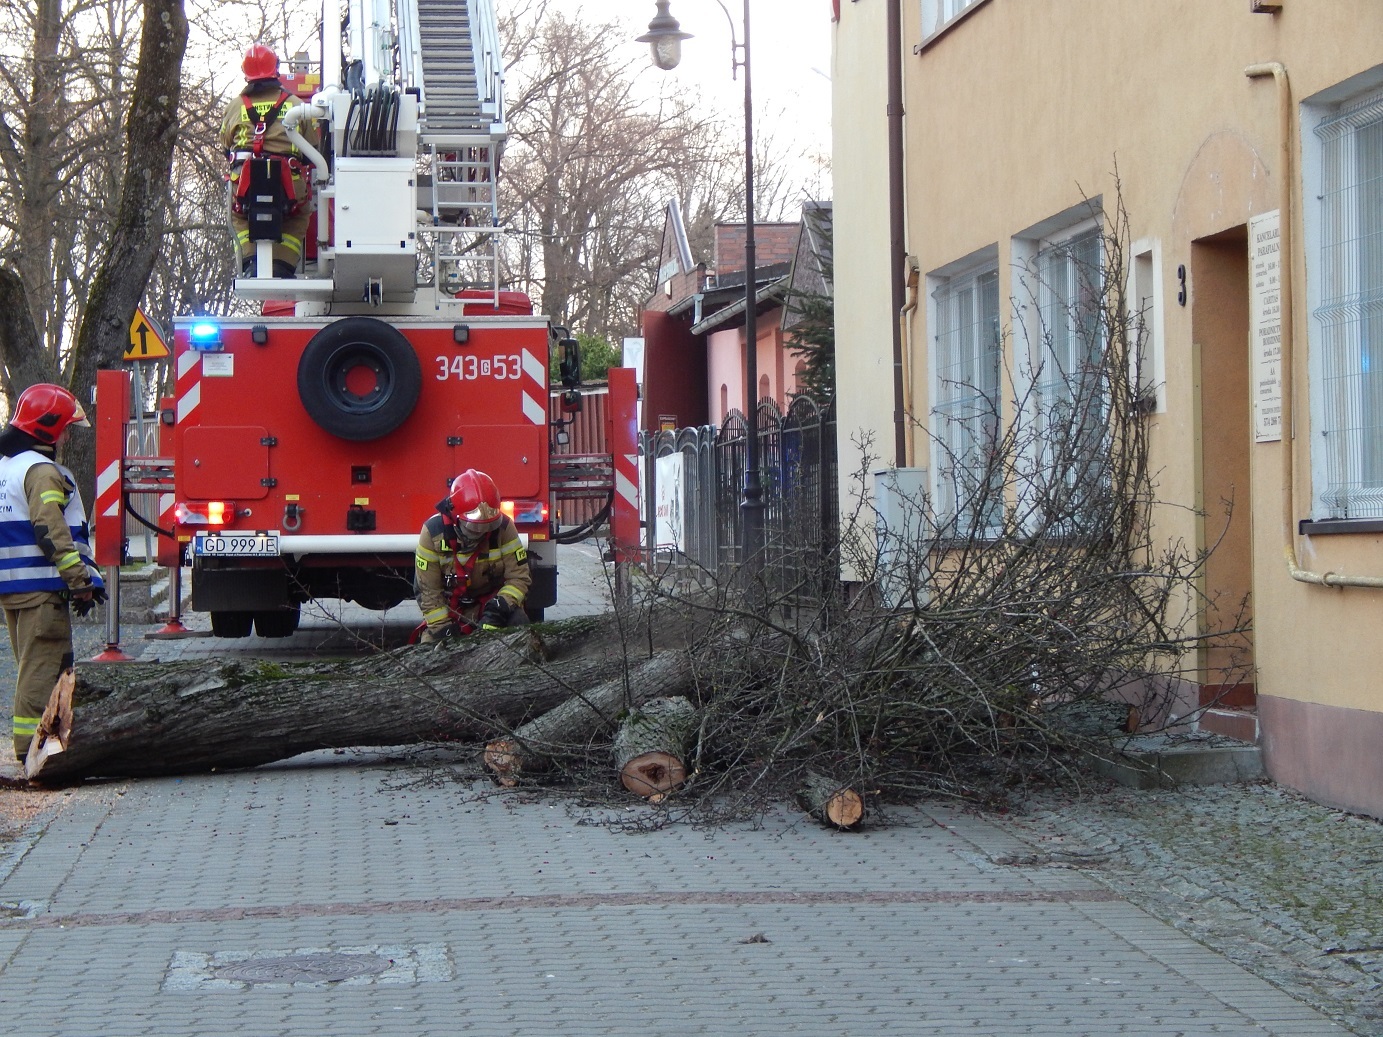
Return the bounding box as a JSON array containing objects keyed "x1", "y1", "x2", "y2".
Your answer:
[{"x1": 831, "y1": 0, "x2": 893, "y2": 561}]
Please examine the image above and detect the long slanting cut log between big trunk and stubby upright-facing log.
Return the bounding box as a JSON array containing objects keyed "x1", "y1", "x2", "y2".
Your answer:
[{"x1": 481, "y1": 651, "x2": 696, "y2": 788}]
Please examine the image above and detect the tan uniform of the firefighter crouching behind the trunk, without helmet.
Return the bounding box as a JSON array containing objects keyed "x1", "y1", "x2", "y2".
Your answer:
[{"x1": 414, "y1": 514, "x2": 532, "y2": 640}]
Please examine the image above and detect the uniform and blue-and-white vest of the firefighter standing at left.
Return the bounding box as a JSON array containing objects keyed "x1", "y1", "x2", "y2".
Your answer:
[{"x1": 0, "y1": 449, "x2": 102, "y2": 760}]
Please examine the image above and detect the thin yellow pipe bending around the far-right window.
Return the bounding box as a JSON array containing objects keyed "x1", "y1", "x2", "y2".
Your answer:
[{"x1": 1243, "y1": 61, "x2": 1383, "y2": 589}]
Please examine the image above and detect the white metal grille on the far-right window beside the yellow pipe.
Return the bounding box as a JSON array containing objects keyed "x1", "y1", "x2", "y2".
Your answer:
[{"x1": 1314, "y1": 94, "x2": 1383, "y2": 519}]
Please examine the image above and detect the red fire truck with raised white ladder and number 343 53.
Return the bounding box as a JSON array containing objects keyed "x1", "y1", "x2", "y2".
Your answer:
[{"x1": 93, "y1": 0, "x2": 638, "y2": 637}]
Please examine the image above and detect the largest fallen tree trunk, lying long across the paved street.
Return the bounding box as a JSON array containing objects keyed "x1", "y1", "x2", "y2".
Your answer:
[{"x1": 30, "y1": 625, "x2": 641, "y2": 784}]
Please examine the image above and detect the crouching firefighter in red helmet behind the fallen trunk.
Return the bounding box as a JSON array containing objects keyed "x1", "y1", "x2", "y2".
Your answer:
[{"x1": 414, "y1": 469, "x2": 532, "y2": 643}]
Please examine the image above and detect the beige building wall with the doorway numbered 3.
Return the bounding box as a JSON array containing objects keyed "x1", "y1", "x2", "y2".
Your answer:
[{"x1": 834, "y1": 0, "x2": 1383, "y2": 814}]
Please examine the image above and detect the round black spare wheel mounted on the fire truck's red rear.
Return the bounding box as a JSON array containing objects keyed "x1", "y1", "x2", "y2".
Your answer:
[{"x1": 297, "y1": 317, "x2": 423, "y2": 442}]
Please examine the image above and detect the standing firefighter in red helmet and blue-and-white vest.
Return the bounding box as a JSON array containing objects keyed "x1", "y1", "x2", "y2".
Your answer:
[{"x1": 0, "y1": 383, "x2": 105, "y2": 760}]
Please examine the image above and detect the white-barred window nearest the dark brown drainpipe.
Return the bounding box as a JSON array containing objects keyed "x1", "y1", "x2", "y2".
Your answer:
[{"x1": 927, "y1": 245, "x2": 1004, "y2": 536}]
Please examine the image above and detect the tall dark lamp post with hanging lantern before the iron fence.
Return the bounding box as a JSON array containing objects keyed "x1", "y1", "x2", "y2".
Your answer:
[{"x1": 639, "y1": 0, "x2": 763, "y2": 574}]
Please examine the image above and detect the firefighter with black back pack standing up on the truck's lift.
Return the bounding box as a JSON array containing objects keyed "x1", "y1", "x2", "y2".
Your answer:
[{"x1": 221, "y1": 43, "x2": 315, "y2": 278}]
